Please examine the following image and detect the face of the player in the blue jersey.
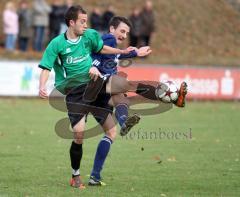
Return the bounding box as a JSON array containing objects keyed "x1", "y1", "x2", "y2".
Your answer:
[{"x1": 110, "y1": 22, "x2": 130, "y2": 44}]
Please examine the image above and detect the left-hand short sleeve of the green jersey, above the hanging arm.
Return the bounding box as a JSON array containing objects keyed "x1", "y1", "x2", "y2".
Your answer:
[{"x1": 38, "y1": 40, "x2": 58, "y2": 71}]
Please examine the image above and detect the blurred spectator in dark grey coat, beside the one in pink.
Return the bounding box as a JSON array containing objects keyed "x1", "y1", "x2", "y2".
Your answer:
[{"x1": 18, "y1": 0, "x2": 32, "y2": 51}]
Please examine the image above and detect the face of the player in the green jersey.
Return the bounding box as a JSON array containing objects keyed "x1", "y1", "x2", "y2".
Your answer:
[{"x1": 72, "y1": 13, "x2": 88, "y2": 36}]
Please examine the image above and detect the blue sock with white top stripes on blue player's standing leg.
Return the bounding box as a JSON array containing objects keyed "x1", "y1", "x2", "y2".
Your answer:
[{"x1": 91, "y1": 136, "x2": 112, "y2": 180}]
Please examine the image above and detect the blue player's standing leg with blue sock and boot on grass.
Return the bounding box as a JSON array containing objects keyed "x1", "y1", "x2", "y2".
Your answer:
[{"x1": 88, "y1": 114, "x2": 117, "y2": 186}]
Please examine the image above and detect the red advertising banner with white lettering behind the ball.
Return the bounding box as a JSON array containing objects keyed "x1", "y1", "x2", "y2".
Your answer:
[{"x1": 120, "y1": 66, "x2": 240, "y2": 100}]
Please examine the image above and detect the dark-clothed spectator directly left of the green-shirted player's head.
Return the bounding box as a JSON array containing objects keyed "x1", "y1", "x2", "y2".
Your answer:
[{"x1": 49, "y1": 0, "x2": 65, "y2": 40}]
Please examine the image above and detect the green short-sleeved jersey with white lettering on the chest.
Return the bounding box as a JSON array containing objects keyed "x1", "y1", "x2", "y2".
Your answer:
[{"x1": 39, "y1": 29, "x2": 103, "y2": 93}]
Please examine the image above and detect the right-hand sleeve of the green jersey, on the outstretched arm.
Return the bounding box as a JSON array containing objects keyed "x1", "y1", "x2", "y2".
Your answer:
[{"x1": 88, "y1": 29, "x2": 103, "y2": 53}]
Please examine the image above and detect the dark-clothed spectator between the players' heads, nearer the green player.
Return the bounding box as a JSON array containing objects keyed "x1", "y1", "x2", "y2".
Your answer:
[{"x1": 90, "y1": 7, "x2": 103, "y2": 34}]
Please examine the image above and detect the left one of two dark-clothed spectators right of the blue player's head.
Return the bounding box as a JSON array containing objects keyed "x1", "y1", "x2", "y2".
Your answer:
[{"x1": 129, "y1": 7, "x2": 142, "y2": 48}]
